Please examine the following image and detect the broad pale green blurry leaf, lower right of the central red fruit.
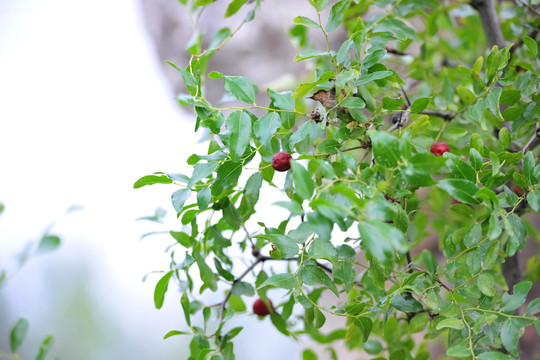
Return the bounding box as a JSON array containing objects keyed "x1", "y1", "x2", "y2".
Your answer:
[{"x1": 358, "y1": 220, "x2": 407, "y2": 261}]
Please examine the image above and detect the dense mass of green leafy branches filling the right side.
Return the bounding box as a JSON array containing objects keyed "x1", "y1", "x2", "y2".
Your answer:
[{"x1": 135, "y1": 0, "x2": 540, "y2": 360}]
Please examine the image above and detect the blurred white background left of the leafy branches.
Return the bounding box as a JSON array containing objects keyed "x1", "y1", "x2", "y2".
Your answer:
[{"x1": 0, "y1": 0, "x2": 300, "y2": 360}]
